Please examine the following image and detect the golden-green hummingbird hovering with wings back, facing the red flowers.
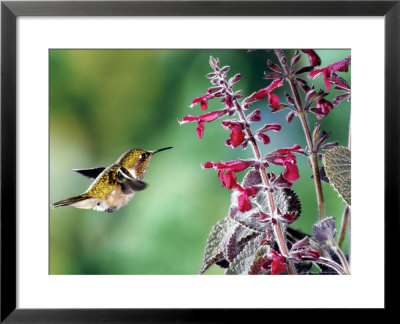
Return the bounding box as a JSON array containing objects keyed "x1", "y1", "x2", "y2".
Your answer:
[{"x1": 52, "y1": 147, "x2": 172, "y2": 213}]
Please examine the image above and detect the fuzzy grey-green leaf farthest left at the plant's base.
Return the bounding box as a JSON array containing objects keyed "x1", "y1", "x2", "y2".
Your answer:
[{"x1": 199, "y1": 217, "x2": 235, "y2": 274}]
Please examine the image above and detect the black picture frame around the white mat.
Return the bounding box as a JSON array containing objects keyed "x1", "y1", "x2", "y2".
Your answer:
[{"x1": 0, "y1": 0, "x2": 400, "y2": 323}]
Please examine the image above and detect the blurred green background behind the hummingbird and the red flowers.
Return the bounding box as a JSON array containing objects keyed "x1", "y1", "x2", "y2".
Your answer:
[{"x1": 49, "y1": 50, "x2": 350, "y2": 274}]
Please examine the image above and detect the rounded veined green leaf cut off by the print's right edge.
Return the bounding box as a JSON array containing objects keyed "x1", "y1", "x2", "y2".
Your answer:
[{"x1": 323, "y1": 146, "x2": 351, "y2": 206}]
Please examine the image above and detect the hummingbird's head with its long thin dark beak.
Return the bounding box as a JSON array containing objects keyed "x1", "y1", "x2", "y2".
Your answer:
[{"x1": 117, "y1": 147, "x2": 172, "y2": 180}]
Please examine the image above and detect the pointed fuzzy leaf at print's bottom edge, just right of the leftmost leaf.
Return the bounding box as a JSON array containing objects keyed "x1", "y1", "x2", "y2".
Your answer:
[{"x1": 226, "y1": 235, "x2": 262, "y2": 274}]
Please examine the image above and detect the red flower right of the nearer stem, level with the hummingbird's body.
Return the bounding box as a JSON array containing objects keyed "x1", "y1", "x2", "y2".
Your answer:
[{"x1": 265, "y1": 144, "x2": 304, "y2": 182}]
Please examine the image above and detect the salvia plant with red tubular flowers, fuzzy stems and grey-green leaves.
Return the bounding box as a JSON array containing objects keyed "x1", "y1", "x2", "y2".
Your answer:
[{"x1": 179, "y1": 49, "x2": 351, "y2": 274}]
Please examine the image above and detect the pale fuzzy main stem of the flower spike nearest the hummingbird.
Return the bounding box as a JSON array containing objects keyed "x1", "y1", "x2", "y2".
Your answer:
[{"x1": 234, "y1": 99, "x2": 296, "y2": 274}]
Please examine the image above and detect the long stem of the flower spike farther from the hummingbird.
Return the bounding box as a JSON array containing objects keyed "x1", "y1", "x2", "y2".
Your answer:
[{"x1": 275, "y1": 50, "x2": 325, "y2": 219}]
